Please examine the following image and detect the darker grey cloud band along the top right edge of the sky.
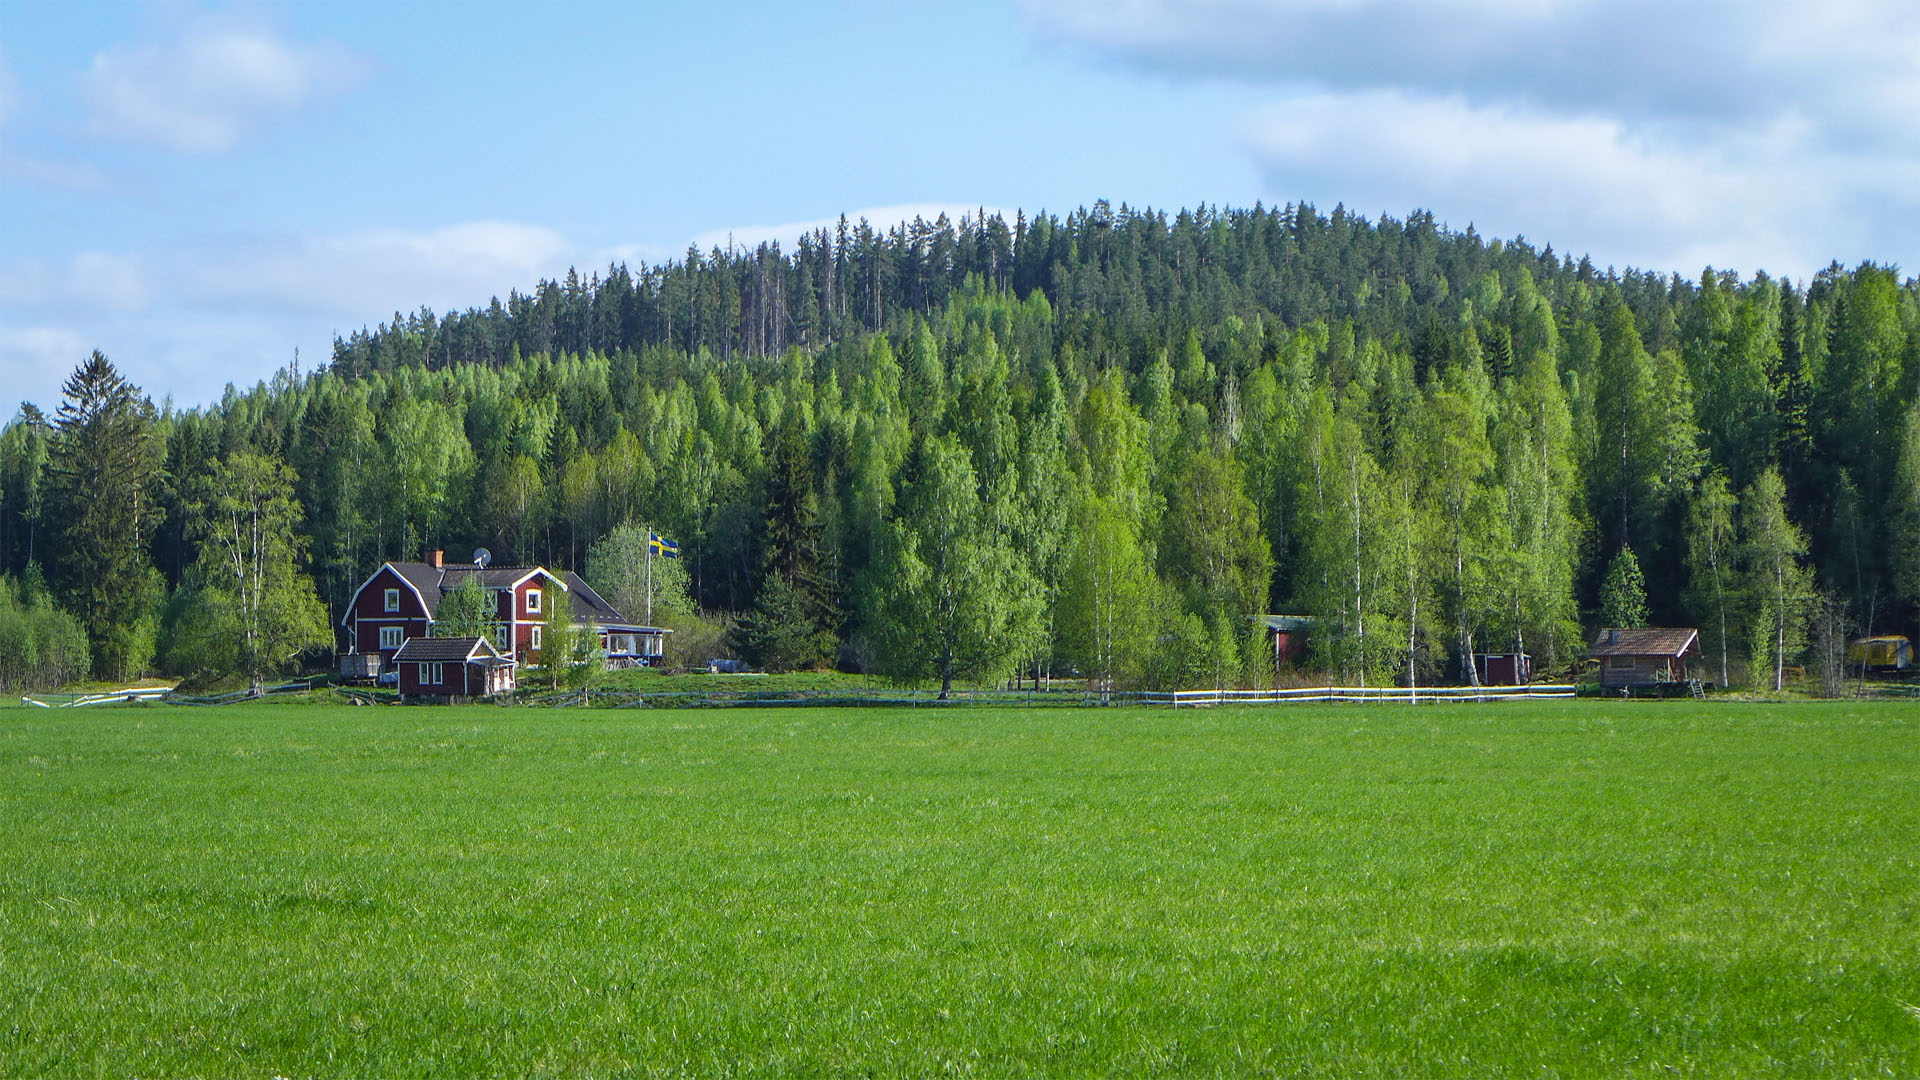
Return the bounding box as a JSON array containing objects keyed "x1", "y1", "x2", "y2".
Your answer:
[{"x1": 1027, "y1": 0, "x2": 1920, "y2": 132}]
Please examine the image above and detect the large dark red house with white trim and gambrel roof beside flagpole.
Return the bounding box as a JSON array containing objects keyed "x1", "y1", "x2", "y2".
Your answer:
[{"x1": 340, "y1": 552, "x2": 672, "y2": 669}]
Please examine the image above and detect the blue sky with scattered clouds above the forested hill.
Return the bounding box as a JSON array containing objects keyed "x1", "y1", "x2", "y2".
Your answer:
[{"x1": 0, "y1": 0, "x2": 1920, "y2": 415}]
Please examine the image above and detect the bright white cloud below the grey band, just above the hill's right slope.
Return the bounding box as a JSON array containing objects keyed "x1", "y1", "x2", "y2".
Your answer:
[{"x1": 1244, "y1": 90, "x2": 1837, "y2": 273}]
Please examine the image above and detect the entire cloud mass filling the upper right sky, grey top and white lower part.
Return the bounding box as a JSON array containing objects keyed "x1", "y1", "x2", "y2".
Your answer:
[{"x1": 1027, "y1": 0, "x2": 1920, "y2": 275}]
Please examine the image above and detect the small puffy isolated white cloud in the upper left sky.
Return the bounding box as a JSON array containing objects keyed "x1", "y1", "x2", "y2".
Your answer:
[{"x1": 81, "y1": 23, "x2": 369, "y2": 154}]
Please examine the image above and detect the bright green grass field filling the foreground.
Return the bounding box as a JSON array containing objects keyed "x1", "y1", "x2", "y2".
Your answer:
[{"x1": 0, "y1": 701, "x2": 1920, "y2": 1078}]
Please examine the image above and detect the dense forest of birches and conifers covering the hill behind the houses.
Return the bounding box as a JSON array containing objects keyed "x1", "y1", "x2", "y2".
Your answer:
[{"x1": 0, "y1": 204, "x2": 1920, "y2": 686}]
